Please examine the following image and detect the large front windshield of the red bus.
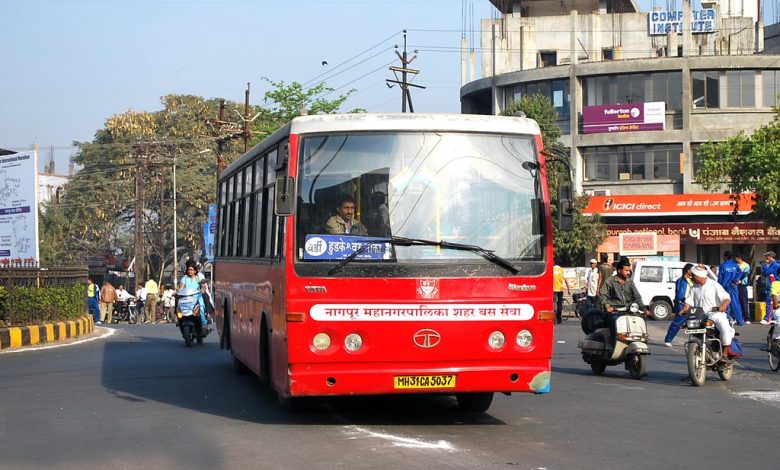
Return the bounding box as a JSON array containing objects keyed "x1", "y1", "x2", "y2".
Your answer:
[{"x1": 296, "y1": 132, "x2": 544, "y2": 265}]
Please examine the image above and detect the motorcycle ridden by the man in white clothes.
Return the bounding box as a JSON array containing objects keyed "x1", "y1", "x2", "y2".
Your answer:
[{"x1": 685, "y1": 307, "x2": 734, "y2": 387}]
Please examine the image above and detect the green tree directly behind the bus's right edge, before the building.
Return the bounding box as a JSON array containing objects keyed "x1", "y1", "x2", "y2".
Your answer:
[{"x1": 502, "y1": 94, "x2": 607, "y2": 266}]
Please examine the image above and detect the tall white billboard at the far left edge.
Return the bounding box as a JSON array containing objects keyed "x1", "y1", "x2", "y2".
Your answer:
[{"x1": 0, "y1": 150, "x2": 38, "y2": 266}]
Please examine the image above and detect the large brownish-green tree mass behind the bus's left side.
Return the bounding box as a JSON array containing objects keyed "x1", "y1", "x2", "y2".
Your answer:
[{"x1": 40, "y1": 80, "x2": 358, "y2": 277}]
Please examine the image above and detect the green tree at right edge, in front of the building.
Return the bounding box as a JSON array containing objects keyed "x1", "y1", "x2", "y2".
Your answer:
[{"x1": 695, "y1": 110, "x2": 780, "y2": 227}]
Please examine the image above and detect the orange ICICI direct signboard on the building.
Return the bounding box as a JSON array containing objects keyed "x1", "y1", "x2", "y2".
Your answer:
[{"x1": 582, "y1": 194, "x2": 755, "y2": 217}]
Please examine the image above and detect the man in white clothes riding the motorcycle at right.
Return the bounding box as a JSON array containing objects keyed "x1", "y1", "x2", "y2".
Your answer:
[{"x1": 683, "y1": 264, "x2": 734, "y2": 357}]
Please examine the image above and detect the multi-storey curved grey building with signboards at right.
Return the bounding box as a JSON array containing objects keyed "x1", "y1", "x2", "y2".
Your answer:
[{"x1": 461, "y1": 0, "x2": 780, "y2": 264}]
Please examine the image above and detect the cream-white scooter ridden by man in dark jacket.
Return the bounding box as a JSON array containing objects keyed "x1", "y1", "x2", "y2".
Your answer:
[{"x1": 578, "y1": 303, "x2": 650, "y2": 380}]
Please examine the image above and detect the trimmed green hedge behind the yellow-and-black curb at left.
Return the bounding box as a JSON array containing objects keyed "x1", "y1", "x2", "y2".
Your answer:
[{"x1": 0, "y1": 285, "x2": 87, "y2": 326}]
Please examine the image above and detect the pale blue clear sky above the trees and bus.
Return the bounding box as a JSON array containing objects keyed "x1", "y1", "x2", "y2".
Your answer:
[{"x1": 0, "y1": 0, "x2": 776, "y2": 174}]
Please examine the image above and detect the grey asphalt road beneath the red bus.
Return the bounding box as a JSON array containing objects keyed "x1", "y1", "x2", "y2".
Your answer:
[{"x1": 0, "y1": 321, "x2": 780, "y2": 469}]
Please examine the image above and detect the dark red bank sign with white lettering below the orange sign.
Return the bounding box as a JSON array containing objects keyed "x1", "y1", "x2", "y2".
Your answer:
[{"x1": 607, "y1": 222, "x2": 780, "y2": 244}]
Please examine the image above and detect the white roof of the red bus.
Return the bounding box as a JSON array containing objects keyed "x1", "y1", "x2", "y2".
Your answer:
[{"x1": 220, "y1": 113, "x2": 540, "y2": 180}]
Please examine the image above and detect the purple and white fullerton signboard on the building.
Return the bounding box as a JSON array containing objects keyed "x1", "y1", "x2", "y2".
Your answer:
[{"x1": 582, "y1": 101, "x2": 666, "y2": 134}]
